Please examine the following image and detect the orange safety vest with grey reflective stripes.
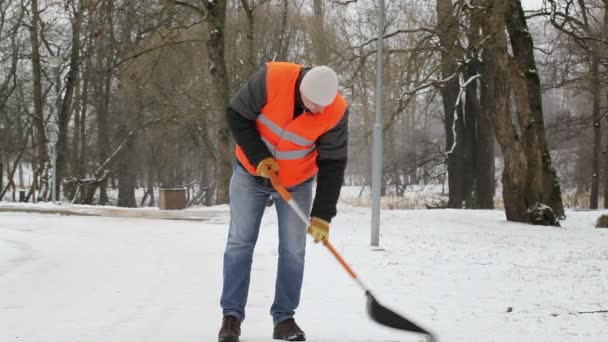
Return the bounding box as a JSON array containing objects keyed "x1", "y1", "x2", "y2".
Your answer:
[{"x1": 235, "y1": 62, "x2": 348, "y2": 187}]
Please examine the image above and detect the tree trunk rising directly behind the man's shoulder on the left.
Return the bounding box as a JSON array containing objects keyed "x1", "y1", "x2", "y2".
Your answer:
[{"x1": 205, "y1": 0, "x2": 232, "y2": 204}]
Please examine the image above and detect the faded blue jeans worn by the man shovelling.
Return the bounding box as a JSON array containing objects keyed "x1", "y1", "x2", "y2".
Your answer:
[{"x1": 220, "y1": 164, "x2": 312, "y2": 324}]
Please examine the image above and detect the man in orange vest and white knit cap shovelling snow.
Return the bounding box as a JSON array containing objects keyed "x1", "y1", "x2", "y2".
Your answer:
[{"x1": 219, "y1": 62, "x2": 348, "y2": 342}]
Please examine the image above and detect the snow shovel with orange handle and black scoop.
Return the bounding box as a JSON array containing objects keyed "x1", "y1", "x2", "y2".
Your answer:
[{"x1": 268, "y1": 171, "x2": 437, "y2": 342}]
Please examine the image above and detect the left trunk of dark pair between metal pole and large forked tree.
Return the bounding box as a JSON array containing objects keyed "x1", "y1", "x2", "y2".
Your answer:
[{"x1": 437, "y1": 0, "x2": 464, "y2": 208}]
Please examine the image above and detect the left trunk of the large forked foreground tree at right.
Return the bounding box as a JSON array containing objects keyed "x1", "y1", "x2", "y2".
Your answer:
[{"x1": 482, "y1": 0, "x2": 528, "y2": 222}]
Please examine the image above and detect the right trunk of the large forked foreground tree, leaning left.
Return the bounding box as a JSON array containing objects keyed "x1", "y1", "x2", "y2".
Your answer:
[{"x1": 506, "y1": 0, "x2": 564, "y2": 217}]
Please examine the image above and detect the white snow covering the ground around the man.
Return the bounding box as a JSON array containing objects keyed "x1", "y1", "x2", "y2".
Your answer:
[{"x1": 0, "y1": 205, "x2": 608, "y2": 342}]
